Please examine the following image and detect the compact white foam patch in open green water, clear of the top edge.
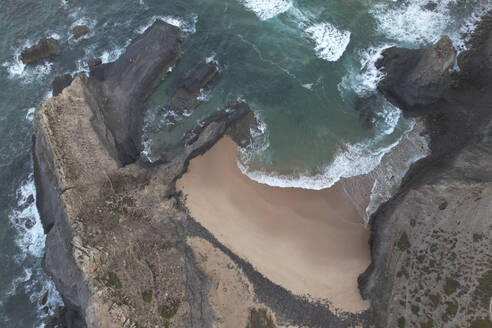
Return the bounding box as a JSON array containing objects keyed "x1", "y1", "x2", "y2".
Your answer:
[{"x1": 306, "y1": 23, "x2": 350, "y2": 61}]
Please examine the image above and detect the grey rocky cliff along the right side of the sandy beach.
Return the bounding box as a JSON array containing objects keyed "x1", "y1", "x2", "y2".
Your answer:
[{"x1": 359, "y1": 12, "x2": 492, "y2": 327}]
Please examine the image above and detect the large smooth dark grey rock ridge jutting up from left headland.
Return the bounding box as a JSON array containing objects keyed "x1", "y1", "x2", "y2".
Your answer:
[{"x1": 89, "y1": 20, "x2": 181, "y2": 165}]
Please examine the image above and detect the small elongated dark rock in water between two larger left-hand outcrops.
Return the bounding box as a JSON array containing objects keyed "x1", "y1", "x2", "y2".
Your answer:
[{"x1": 166, "y1": 62, "x2": 218, "y2": 114}]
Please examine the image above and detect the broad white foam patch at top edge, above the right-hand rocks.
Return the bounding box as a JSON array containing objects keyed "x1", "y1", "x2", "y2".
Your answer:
[{"x1": 370, "y1": 0, "x2": 455, "y2": 45}]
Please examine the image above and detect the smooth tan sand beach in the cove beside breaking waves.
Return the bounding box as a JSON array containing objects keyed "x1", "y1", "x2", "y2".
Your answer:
[{"x1": 177, "y1": 137, "x2": 370, "y2": 312}]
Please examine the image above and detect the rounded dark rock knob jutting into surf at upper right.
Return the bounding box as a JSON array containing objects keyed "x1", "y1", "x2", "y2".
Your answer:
[{"x1": 376, "y1": 36, "x2": 456, "y2": 110}]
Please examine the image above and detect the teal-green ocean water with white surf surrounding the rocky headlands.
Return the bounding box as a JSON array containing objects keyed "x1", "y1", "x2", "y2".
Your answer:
[{"x1": 0, "y1": 0, "x2": 490, "y2": 327}]
